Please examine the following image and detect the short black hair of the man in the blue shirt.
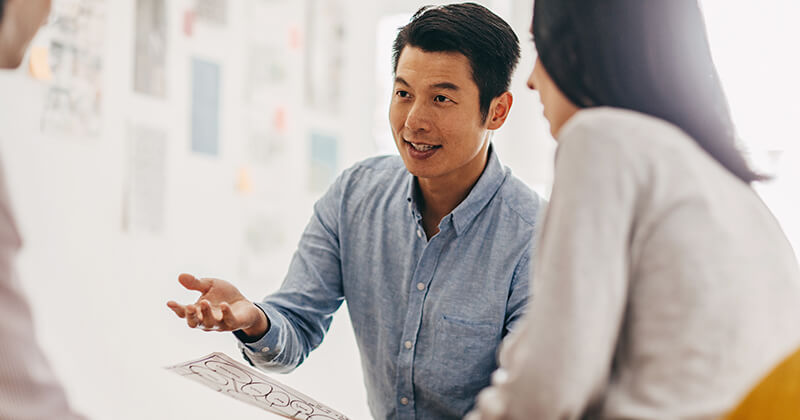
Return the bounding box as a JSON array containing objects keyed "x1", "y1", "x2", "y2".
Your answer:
[{"x1": 392, "y1": 3, "x2": 520, "y2": 120}]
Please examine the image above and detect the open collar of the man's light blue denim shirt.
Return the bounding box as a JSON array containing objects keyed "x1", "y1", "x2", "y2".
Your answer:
[{"x1": 406, "y1": 144, "x2": 507, "y2": 235}]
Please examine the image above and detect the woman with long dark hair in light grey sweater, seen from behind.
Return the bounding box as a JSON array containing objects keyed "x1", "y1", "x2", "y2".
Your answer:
[{"x1": 468, "y1": 0, "x2": 800, "y2": 419}]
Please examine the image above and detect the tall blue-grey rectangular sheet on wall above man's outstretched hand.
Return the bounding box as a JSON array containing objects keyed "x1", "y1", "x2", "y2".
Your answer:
[{"x1": 191, "y1": 58, "x2": 220, "y2": 156}]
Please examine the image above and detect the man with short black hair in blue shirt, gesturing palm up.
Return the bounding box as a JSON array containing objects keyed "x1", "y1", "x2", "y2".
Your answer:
[{"x1": 168, "y1": 4, "x2": 540, "y2": 419}]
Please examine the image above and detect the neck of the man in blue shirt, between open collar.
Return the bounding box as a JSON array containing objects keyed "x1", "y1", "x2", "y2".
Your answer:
[{"x1": 417, "y1": 142, "x2": 489, "y2": 239}]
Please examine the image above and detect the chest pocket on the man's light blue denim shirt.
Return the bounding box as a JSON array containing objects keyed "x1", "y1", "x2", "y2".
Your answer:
[{"x1": 431, "y1": 315, "x2": 502, "y2": 415}]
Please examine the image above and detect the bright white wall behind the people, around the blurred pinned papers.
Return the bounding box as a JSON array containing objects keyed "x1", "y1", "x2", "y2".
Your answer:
[{"x1": 0, "y1": 0, "x2": 800, "y2": 420}]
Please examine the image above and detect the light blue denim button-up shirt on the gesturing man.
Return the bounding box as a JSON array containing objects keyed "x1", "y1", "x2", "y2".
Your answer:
[{"x1": 240, "y1": 148, "x2": 542, "y2": 420}]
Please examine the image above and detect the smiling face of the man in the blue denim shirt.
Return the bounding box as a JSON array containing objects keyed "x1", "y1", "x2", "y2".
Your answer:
[{"x1": 389, "y1": 46, "x2": 494, "y2": 183}]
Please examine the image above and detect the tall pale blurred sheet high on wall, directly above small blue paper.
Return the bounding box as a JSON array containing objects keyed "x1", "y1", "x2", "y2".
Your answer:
[{"x1": 305, "y1": 0, "x2": 345, "y2": 114}]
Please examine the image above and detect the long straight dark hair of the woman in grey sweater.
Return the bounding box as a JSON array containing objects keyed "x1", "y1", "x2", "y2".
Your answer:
[{"x1": 533, "y1": 0, "x2": 767, "y2": 183}]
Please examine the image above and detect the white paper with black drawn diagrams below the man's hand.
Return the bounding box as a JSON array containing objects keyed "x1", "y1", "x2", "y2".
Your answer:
[{"x1": 166, "y1": 353, "x2": 349, "y2": 420}]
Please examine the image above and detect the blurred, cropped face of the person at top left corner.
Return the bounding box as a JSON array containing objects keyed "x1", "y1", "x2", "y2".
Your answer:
[{"x1": 0, "y1": 0, "x2": 51, "y2": 68}]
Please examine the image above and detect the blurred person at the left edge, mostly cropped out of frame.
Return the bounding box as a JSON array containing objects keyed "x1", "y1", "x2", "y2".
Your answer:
[{"x1": 0, "y1": 0, "x2": 85, "y2": 420}]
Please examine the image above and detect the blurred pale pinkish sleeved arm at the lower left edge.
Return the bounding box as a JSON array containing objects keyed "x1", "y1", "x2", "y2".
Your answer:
[{"x1": 0, "y1": 163, "x2": 81, "y2": 420}]
